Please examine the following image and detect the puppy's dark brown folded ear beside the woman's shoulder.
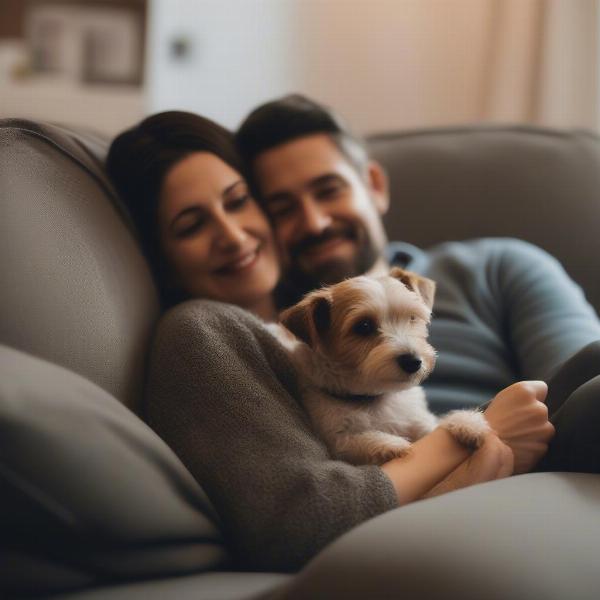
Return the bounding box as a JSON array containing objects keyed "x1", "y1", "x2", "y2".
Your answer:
[{"x1": 279, "y1": 290, "x2": 331, "y2": 348}]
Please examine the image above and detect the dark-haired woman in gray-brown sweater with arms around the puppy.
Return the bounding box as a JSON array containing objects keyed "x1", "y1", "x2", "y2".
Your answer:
[{"x1": 107, "y1": 112, "x2": 552, "y2": 570}]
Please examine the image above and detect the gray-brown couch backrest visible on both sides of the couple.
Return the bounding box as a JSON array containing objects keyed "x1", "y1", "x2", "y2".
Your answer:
[{"x1": 0, "y1": 119, "x2": 600, "y2": 408}]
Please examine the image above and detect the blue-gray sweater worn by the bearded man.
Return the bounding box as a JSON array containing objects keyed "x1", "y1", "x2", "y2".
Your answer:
[{"x1": 388, "y1": 238, "x2": 600, "y2": 412}]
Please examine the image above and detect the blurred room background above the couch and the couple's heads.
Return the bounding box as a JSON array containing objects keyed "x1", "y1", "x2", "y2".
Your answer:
[{"x1": 0, "y1": 0, "x2": 600, "y2": 135}]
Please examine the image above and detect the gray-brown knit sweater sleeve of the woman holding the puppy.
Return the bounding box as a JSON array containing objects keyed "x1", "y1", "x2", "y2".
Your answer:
[{"x1": 145, "y1": 301, "x2": 397, "y2": 571}]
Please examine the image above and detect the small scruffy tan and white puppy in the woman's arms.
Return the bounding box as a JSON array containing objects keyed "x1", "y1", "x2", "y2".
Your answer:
[{"x1": 269, "y1": 268, "x2": 489, "y2": 464}]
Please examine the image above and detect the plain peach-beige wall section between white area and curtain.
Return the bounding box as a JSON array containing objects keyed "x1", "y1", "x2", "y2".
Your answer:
[{"x1": 292, "y1": 0, "x2": 490, "y2": 131}]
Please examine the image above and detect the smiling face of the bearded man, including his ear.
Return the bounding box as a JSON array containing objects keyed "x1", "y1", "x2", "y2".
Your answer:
[{"x1": 252, "y1": 134, "x2": 388, "y2": 288}]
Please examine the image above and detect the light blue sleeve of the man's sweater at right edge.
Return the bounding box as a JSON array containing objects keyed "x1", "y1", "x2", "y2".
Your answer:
[{"x1": 496, "y1": 240, "x2": 600, "y2": 379}]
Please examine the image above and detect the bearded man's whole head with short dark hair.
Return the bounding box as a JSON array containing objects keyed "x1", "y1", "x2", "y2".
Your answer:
[{"x1": 237, "y1": 96, "x2": 388, "y2": 300}]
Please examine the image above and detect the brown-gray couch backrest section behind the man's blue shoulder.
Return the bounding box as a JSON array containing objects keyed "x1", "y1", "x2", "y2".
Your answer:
[{"x1": 370, "y1": 125, "x2": 600, "y2": 312}]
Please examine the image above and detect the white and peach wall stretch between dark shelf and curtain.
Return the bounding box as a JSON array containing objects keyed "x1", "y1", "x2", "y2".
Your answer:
[{"x1": 147, "y1": 0, "x2": 502, "y2": 132}]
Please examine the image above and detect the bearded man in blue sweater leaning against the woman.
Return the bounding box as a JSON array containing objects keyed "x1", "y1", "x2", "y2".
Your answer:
[{"x1": 237, "y1": 95, "x2": 600, "y2": 470}]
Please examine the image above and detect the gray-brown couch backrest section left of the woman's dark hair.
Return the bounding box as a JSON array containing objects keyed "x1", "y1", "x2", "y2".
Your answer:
[{"x1": 0, "y1": 119, "x2": 158, "y2": 408}]
